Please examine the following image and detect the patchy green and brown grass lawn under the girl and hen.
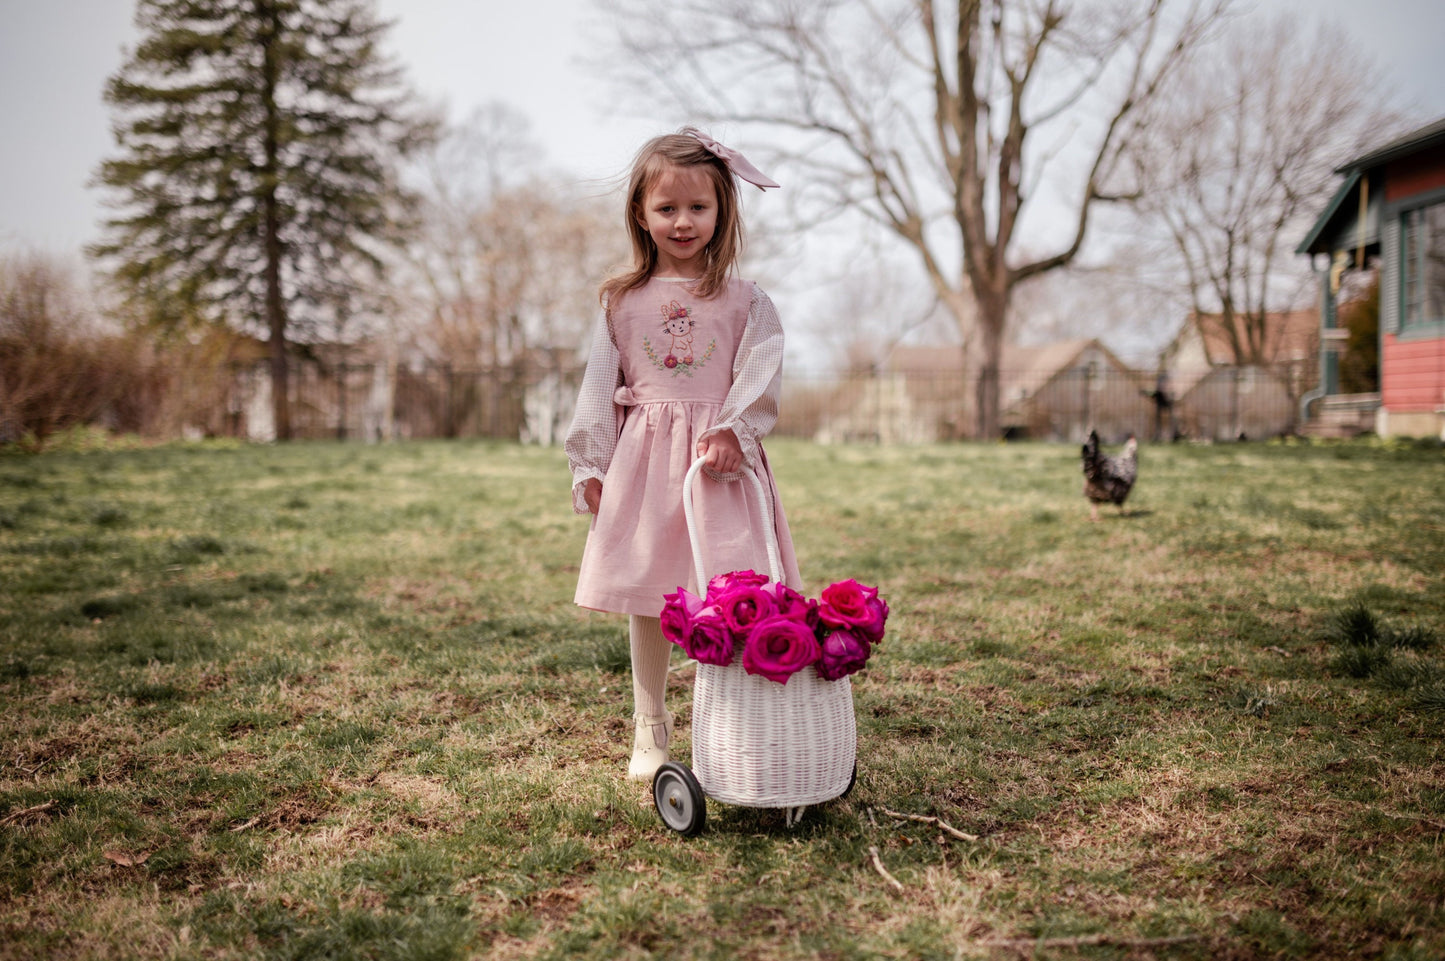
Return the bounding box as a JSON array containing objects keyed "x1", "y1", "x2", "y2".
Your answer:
[{"x1": 0, "y1": 441, "x2": 1445, "y2": 961}]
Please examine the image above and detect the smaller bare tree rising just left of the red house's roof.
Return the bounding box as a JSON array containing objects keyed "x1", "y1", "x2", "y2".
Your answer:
[{"x1": 1131, "y1": 16, "x2": 1390, "y2": 366}]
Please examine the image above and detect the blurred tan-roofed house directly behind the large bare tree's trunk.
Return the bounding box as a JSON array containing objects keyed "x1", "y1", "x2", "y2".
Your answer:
[{"x1": 815, "y1": 340, "x2": 1153, "y2": 444}]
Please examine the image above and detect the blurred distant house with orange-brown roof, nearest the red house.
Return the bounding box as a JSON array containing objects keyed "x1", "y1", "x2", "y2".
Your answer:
[{"x1": 1155, "y1": 311, "x2": 1319, "y2": 441}]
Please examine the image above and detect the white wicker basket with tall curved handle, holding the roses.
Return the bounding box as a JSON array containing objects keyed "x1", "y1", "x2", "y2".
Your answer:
[{"x1": 682, "y1": 460, "x2": 858, "y2": 809}]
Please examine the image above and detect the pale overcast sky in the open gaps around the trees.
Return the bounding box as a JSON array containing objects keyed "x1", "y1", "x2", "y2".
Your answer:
[{"x1": 0, "y1": 0, "x2": 1445, "y2": 253}]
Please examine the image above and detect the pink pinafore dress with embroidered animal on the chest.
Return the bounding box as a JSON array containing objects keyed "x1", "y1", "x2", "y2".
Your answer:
[{"x1": 574, "y1": 279, "x2": 801, "y2": 617}]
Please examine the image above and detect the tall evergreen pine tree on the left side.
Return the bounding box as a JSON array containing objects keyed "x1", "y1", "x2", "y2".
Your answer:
[{"x1": 92, "y1": 0, "x2": 434, "y2": 439}]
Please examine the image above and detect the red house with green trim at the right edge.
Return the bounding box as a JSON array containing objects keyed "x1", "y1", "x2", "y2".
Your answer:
[{"x1": 1296, "y1": 118, "x2": 1445, "y2": 438}]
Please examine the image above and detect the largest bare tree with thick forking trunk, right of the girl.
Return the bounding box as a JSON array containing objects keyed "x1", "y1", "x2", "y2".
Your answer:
[{"x1": 595, "y1": 0, "x2": 1228, "y2": 436}]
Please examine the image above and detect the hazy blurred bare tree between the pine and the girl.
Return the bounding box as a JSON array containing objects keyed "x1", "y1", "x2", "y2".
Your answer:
[{"x1": 396, "y1": 105, "x2": 623, "y2": 433}]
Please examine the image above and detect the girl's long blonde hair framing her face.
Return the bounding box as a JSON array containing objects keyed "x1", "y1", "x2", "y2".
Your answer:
[{"x1": 600, "y1": 127, "x2": 743, "y2": 305}]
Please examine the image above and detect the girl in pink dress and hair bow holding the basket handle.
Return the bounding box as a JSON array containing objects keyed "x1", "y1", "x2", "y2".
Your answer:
[{"x1": 566, "y1": 127, "x2": 801, "y2": 780}]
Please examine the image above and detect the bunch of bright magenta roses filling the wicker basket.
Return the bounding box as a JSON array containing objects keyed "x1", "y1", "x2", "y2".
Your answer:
[{"x1": 662, "y1": 571, "x2": 889, "y2": 684}]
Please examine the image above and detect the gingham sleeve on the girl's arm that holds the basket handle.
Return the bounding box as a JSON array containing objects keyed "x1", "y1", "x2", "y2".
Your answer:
[{"x1": 699, "y1": 285, "x2": 783, "y2": 477}]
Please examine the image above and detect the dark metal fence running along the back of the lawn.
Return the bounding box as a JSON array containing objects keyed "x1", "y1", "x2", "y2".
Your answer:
[{"x1": 103, "y1": 361, "x2": 1301, "y2": 444}]
